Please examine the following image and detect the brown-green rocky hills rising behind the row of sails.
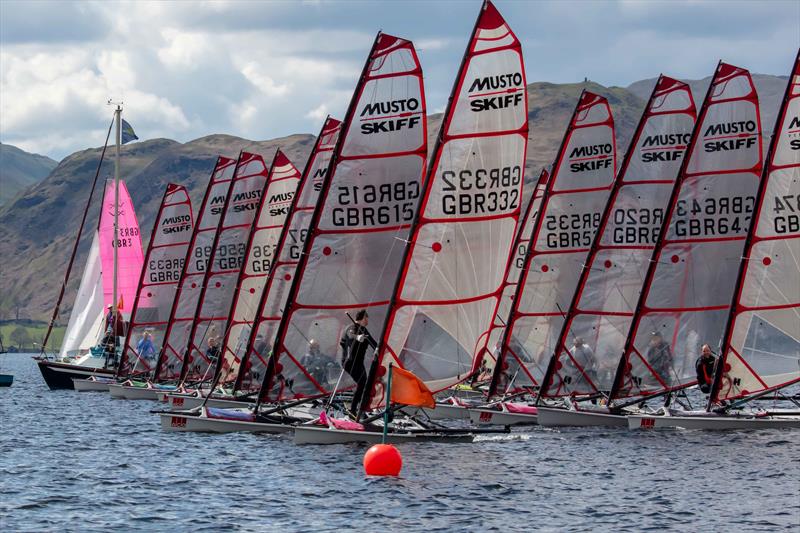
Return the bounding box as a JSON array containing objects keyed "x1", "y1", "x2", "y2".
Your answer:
[{"x1": 0, "y1": 76, "x2": 786, "y2": 322}]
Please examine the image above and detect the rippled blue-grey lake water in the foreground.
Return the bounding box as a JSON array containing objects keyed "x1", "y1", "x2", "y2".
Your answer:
[{"x1": 0, "y1": 354, "x2": 800, "y2": 532}]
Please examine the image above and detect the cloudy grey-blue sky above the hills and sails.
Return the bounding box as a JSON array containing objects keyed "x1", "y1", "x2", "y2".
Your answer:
[{"x1": 0, "y1": 0, "x2": 800, "y2": 159}]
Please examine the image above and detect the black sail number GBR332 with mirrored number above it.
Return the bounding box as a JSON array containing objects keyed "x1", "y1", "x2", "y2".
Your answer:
[{"x1": 441, "y1": 166, "x2": 522, "y2": 216}]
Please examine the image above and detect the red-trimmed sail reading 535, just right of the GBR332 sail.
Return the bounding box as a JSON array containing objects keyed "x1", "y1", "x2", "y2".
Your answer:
[{"x1": 493, "y1": 91, "x2": 617, "y2": 390}]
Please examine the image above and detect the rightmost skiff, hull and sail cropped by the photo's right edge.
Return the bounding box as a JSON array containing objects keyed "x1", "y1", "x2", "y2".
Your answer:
[{"x1": 628, "y1": 53, "x2": 800, "y2": 429}]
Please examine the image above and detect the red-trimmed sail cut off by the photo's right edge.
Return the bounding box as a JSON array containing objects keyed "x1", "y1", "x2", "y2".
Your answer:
[{"x1": 714, "y1": 55, "x2": 800, "y2": 401}]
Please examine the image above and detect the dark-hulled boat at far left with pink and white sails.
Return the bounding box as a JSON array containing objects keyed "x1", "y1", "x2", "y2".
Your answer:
[{"x1": 36, "y1": 106, "x2": 143, "y2": 389}]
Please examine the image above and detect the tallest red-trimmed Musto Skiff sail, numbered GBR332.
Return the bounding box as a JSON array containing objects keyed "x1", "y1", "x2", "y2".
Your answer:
[{"x1": 372, "y1": 2, "x2": 528, "y2": 400}]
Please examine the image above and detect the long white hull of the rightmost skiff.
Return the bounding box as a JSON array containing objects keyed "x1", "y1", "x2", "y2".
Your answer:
[{"x1": 628, "y1": 415, "x2": 800, "y2": 430}]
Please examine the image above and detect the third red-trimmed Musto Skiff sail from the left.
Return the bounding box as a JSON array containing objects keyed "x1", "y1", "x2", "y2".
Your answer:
[{"x1": 181, "y1": 152, "x2": 268, "y2": 382}]
